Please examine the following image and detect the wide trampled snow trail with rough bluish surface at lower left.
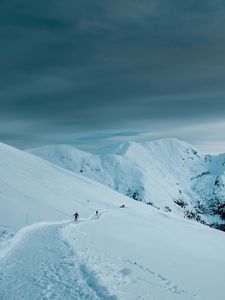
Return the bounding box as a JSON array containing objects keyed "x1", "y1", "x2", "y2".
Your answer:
[{"x1": 0, "y1": 221, "x2": 117, "y2": 300}]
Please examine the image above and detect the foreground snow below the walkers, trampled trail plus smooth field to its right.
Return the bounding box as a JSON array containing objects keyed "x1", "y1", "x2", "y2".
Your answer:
[{"x1": 0, "y1": 205, "x2": 225, "y2": 300}]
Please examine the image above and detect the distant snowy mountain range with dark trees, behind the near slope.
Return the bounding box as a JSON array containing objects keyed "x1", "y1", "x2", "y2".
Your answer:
[{"x1": 29, "y1": 139, "x2": 225, "y2": 226}]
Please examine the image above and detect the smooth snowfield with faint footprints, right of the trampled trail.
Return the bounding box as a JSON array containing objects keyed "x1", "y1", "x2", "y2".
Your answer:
[{"x1": 63, "y1": 208, "x2": 225, "y2": 300}]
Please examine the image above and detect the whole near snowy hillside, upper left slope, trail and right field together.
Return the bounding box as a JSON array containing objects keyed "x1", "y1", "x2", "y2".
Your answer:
[{"x1": 0, "y1": 144, "x2": 225, "y2": 300}]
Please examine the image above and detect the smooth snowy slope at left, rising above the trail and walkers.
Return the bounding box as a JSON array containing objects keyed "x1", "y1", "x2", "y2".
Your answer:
[{"x1": 0, "y1": 144, "x2": 134, "y2": 228}]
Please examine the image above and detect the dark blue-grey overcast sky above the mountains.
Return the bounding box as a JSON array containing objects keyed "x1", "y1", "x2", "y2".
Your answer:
[{"x1": 0, "y1": 0, "x2": 225, "y2": 153}]
